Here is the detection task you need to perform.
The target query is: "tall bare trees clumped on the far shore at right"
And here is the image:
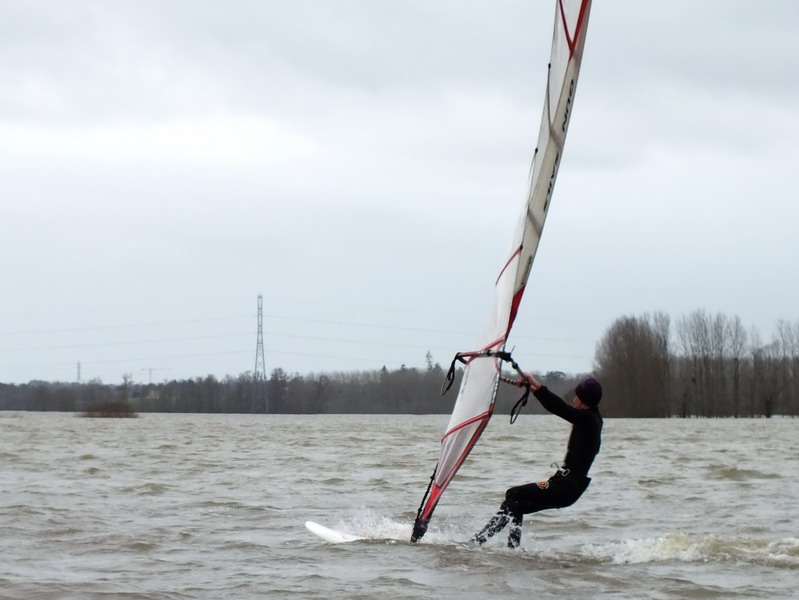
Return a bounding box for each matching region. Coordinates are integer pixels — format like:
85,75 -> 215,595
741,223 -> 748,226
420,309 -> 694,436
594,310 -> 799,417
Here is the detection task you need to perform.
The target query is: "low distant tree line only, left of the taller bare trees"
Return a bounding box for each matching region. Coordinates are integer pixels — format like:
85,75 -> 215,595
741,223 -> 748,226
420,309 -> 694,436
0,355 -> 577,414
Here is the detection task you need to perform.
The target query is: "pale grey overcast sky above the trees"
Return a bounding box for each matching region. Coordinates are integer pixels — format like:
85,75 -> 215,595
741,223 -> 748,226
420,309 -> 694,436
0,0 -> 799,383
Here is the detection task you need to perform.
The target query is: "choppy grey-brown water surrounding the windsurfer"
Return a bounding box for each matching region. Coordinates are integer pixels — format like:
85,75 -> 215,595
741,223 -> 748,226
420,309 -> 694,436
0,413 -> 799,600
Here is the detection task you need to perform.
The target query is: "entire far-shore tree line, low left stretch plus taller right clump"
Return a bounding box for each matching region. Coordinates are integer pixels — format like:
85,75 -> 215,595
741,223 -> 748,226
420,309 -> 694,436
0,310 -> 799,417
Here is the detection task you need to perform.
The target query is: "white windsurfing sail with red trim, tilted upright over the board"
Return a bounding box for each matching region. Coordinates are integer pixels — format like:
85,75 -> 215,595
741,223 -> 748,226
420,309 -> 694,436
411,0 -> 591,542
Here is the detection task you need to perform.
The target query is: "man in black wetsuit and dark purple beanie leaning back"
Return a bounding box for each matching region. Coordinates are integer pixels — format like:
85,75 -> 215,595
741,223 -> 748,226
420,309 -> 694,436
471,373 -> 602,548
